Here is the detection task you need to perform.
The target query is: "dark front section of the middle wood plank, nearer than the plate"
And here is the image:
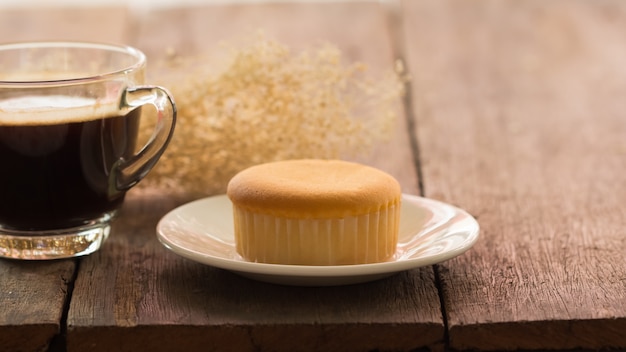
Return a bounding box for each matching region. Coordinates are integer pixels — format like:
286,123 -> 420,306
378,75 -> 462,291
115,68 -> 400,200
67,195 -> 443,351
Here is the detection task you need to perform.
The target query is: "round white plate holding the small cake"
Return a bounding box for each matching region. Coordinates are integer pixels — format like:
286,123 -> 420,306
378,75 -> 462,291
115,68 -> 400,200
157,194 -> 479,286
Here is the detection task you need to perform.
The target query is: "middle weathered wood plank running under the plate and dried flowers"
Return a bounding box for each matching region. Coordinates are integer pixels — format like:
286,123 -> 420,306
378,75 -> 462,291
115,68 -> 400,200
68,4 -> 444,351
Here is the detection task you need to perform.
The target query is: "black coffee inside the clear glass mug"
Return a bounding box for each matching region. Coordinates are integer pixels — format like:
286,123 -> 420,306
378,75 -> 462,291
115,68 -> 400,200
0,95 -> 140,230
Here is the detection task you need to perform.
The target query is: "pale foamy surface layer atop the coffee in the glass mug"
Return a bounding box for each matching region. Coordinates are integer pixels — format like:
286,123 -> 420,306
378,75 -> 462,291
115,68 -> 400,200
0,95 -> 119,126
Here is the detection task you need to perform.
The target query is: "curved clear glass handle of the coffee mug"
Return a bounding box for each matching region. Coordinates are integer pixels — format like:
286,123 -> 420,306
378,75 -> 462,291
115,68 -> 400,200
112,86 -> 176,191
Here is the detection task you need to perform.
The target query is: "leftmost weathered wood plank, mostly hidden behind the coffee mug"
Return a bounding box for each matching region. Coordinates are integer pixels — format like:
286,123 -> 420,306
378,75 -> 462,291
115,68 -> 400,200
0,8 -> 132,351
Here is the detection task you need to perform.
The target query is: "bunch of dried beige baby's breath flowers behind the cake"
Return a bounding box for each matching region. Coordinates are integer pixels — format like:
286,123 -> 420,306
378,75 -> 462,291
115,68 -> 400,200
143,34 -> 402,195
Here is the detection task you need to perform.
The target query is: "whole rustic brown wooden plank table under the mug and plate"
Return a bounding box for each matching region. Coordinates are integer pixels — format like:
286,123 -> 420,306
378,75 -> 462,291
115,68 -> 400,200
0,0 -> 626,351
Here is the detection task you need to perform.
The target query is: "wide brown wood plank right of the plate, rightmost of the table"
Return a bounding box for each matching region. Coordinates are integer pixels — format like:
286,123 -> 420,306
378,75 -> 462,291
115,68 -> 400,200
403,0 -> 626,350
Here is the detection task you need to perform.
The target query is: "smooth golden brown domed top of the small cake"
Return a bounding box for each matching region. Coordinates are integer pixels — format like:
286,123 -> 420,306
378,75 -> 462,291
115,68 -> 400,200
227,159 -> 401,218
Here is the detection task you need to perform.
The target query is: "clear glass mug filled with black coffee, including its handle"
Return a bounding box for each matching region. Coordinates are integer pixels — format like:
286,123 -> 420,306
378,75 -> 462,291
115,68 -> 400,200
0,42 -> 176,259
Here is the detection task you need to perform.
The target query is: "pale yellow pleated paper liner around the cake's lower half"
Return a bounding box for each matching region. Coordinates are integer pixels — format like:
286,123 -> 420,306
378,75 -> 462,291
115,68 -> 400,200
233,204 -> 400,265
